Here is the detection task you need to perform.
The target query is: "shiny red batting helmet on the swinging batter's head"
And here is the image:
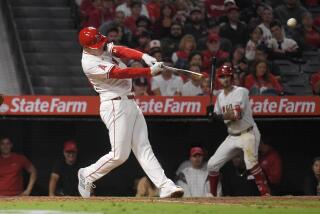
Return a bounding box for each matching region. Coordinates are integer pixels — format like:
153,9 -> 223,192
79,27 -> 108,49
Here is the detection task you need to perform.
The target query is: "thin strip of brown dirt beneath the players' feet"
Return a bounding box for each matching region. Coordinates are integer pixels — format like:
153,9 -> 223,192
0,196 -> 320,208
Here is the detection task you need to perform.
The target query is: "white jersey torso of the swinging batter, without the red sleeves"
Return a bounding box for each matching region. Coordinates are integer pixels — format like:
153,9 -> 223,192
81,43 -> 132,101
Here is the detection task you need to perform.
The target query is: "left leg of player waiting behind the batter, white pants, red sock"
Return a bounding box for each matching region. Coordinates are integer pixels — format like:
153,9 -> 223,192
208,136 -> 238,196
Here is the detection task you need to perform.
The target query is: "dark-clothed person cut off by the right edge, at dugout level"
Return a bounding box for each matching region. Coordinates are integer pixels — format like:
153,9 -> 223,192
303,157 -> 320,196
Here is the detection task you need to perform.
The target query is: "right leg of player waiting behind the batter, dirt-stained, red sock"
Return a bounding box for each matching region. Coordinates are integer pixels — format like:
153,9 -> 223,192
239,128 -> 270,195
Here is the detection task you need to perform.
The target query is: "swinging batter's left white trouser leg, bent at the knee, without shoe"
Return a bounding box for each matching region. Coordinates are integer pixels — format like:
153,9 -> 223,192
84,100 -> 136,182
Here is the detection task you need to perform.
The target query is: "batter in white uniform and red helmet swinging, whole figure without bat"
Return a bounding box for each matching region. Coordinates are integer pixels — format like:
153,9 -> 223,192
78,27 -> 184,198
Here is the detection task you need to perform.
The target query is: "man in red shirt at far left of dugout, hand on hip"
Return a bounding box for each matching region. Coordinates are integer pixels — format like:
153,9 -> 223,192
0,137 -> 37,196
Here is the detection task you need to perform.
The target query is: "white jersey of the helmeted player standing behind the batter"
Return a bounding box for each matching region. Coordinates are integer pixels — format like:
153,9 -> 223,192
214,86 -> 256,133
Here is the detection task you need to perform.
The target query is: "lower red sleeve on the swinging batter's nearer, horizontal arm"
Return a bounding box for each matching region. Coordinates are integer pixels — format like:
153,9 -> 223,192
107,66 -> 151,79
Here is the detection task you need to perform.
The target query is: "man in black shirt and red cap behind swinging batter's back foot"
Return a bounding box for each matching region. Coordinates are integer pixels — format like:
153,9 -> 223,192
49,141 -> 80,196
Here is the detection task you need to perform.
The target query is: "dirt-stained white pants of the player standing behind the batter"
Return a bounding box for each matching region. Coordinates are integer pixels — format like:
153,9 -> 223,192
208,126 -> 261,172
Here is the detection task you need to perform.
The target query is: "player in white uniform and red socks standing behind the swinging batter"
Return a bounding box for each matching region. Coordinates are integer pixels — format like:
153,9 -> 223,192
208,65 -> 270,195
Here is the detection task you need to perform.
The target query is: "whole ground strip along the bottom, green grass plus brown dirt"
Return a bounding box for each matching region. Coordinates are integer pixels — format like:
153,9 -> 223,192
0,197 -> 320,214
